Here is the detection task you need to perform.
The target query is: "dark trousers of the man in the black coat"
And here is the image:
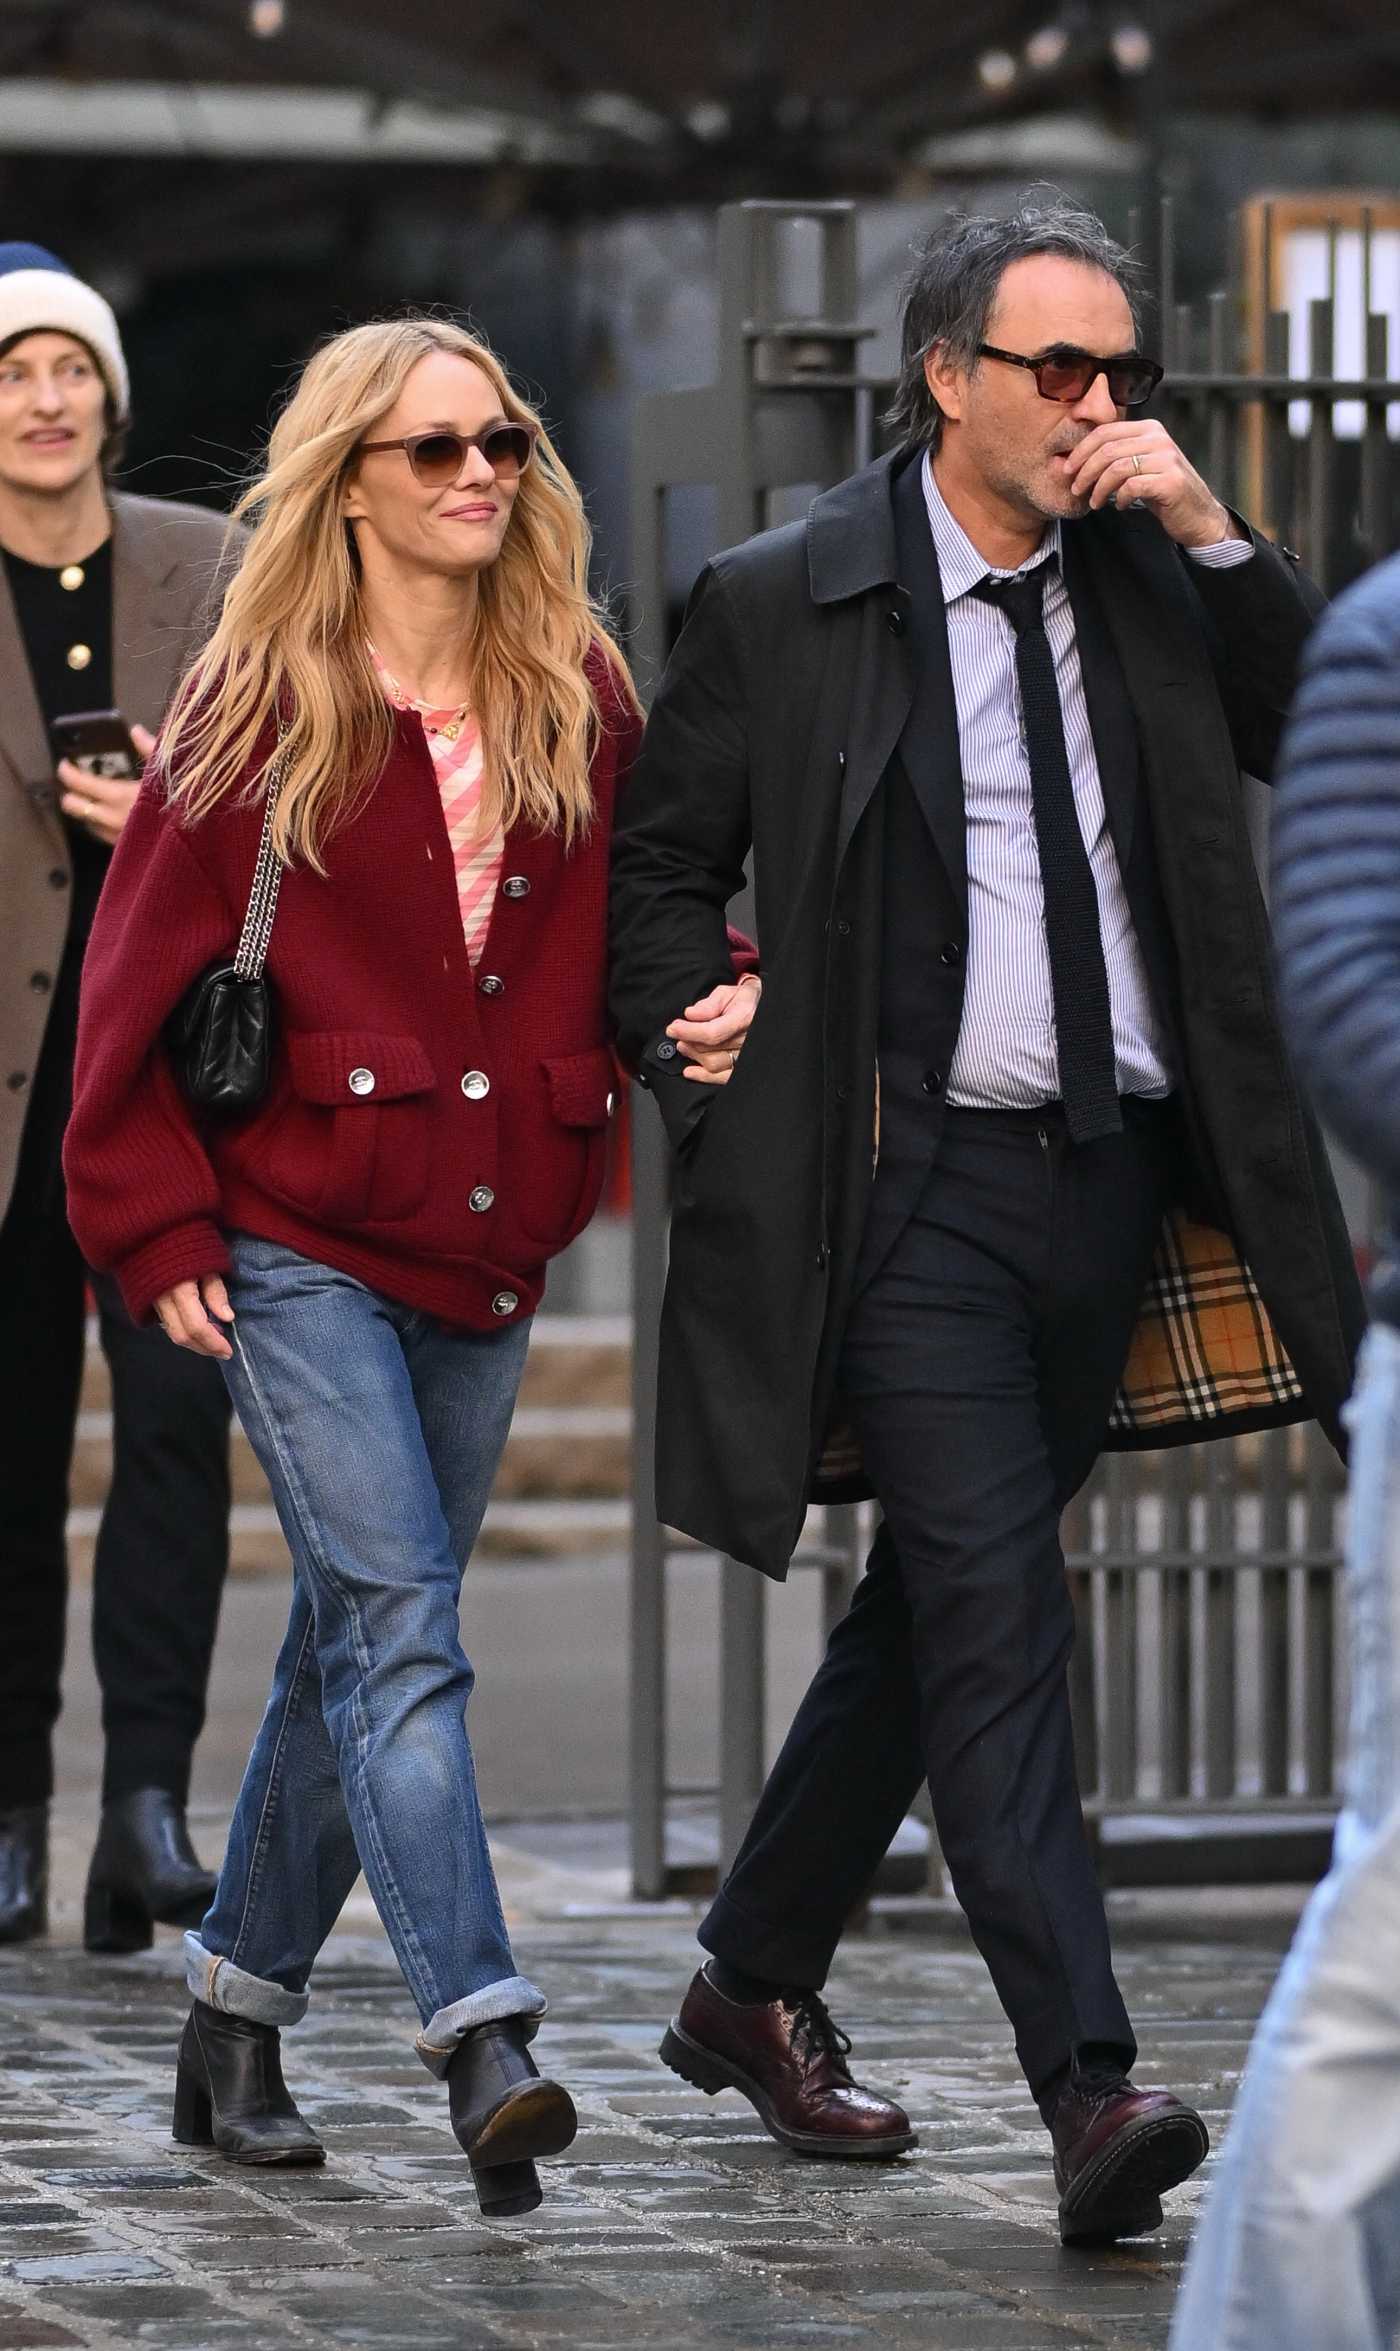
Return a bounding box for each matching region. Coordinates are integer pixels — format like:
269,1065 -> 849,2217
701,1100 -> 1179,2095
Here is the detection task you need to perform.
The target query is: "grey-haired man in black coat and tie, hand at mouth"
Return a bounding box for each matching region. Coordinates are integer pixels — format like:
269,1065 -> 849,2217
614,197 -> 1360,2243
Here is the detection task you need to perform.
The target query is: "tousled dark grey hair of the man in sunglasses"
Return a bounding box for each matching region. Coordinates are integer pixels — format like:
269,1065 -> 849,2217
885,188 -> 1146,449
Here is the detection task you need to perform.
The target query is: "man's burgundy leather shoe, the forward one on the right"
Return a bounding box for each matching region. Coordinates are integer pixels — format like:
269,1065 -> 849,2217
1049,2067 -> 1209,2245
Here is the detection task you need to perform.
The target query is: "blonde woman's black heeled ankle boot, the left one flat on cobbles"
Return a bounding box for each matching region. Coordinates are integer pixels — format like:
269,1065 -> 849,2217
172,2001 -> 325,2163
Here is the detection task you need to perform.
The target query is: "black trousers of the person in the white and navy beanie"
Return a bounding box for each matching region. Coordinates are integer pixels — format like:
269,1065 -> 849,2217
0,1168 -> 228,1808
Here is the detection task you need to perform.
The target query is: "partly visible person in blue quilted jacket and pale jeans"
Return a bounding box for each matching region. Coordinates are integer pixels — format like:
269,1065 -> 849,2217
1172,557 -> 1400,2351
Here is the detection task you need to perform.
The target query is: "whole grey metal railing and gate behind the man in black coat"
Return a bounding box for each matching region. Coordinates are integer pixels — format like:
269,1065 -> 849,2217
631,205 -> 1400,1897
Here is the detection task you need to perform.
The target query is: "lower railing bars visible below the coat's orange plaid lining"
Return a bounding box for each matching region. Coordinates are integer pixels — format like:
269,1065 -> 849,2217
1064,1425 -> 1346,1881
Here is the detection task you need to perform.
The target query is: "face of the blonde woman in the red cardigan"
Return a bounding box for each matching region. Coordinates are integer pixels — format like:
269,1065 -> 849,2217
346,350 -> 520,578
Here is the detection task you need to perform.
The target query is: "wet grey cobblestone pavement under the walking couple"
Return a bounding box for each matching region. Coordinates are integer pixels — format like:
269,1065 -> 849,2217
0,1848 -> 1308,2351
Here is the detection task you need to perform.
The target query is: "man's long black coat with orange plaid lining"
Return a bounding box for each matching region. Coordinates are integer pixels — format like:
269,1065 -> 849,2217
612,444 -> 1362,1578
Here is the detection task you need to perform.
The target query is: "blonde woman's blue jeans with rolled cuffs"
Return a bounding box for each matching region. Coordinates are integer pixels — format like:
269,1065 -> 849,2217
186,1232 -> 546,2074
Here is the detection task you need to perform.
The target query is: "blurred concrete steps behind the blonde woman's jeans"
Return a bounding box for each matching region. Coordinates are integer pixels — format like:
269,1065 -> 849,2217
68,1312 -> 631,1578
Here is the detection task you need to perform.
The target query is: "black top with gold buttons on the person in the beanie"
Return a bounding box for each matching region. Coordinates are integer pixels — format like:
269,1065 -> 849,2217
0,538 -> 113,1215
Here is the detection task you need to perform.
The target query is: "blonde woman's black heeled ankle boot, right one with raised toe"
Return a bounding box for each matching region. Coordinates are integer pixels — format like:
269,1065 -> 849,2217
447,2017 -> 579,2219
